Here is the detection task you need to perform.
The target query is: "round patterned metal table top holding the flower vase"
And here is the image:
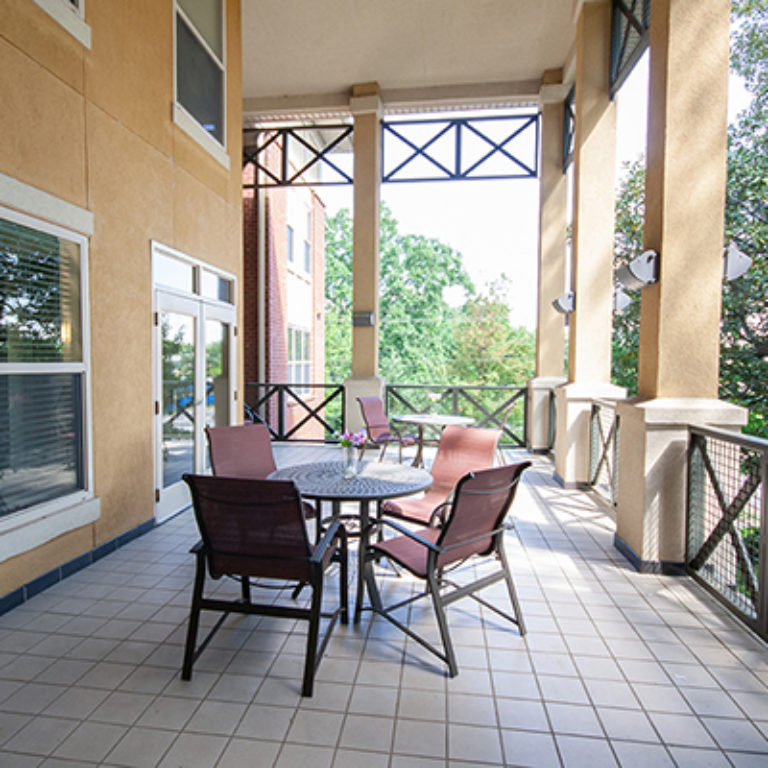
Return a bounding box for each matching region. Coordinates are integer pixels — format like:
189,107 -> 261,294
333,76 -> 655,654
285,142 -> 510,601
269,460 -> 432,501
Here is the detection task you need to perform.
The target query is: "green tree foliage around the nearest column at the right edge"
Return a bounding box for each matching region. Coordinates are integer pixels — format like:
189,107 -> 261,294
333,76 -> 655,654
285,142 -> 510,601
613,0 -> 768,437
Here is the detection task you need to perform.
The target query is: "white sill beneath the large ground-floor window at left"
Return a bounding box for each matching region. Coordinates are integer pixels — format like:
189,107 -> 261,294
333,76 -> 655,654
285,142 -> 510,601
0,495 -> 101,562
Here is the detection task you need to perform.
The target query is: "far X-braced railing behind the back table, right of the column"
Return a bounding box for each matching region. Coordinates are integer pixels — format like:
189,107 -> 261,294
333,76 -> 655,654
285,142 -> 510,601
386,384 -> 527,448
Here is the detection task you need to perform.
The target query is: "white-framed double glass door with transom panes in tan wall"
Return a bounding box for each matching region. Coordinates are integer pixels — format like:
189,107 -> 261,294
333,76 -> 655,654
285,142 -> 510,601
154,291 -> 235,519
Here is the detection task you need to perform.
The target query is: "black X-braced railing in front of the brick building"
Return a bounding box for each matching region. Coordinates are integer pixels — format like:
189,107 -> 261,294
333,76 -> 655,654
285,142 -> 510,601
243,382 -> 345,443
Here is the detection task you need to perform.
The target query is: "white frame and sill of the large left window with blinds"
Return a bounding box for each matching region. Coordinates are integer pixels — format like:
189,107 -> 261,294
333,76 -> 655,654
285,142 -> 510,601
0,204 -> 100,562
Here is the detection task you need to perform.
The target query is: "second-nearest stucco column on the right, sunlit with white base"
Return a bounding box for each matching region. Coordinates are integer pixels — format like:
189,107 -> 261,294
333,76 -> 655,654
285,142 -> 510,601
555,0 -> 625,485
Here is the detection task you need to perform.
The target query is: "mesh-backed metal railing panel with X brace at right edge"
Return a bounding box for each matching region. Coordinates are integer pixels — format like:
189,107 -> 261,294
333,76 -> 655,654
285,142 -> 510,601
685,427 -> 768,639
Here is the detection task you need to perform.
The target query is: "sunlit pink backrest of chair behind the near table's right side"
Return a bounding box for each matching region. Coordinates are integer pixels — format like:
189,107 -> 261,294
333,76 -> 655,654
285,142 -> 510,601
429,424 -> 501,499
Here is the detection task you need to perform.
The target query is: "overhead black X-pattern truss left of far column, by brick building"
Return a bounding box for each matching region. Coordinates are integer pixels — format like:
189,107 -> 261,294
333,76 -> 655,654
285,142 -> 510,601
243,124 -> 352,189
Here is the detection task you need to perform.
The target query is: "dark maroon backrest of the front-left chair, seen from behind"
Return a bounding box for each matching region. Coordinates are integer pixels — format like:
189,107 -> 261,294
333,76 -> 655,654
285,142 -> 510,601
183,474 -> 312,581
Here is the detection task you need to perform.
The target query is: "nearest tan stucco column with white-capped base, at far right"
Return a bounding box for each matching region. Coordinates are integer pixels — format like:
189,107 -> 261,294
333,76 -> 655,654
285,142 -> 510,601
616,0 -> 747,570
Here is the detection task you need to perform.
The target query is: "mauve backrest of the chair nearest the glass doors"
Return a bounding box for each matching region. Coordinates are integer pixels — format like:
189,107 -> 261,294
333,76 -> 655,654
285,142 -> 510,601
205,424 -> 277,480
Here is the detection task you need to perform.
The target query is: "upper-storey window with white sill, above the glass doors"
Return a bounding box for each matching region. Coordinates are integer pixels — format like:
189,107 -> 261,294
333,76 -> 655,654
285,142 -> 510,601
175,0 -> 226,162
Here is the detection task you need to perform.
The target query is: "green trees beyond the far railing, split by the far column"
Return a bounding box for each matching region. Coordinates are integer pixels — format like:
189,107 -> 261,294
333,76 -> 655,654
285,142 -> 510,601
325,206 -> 534,385
